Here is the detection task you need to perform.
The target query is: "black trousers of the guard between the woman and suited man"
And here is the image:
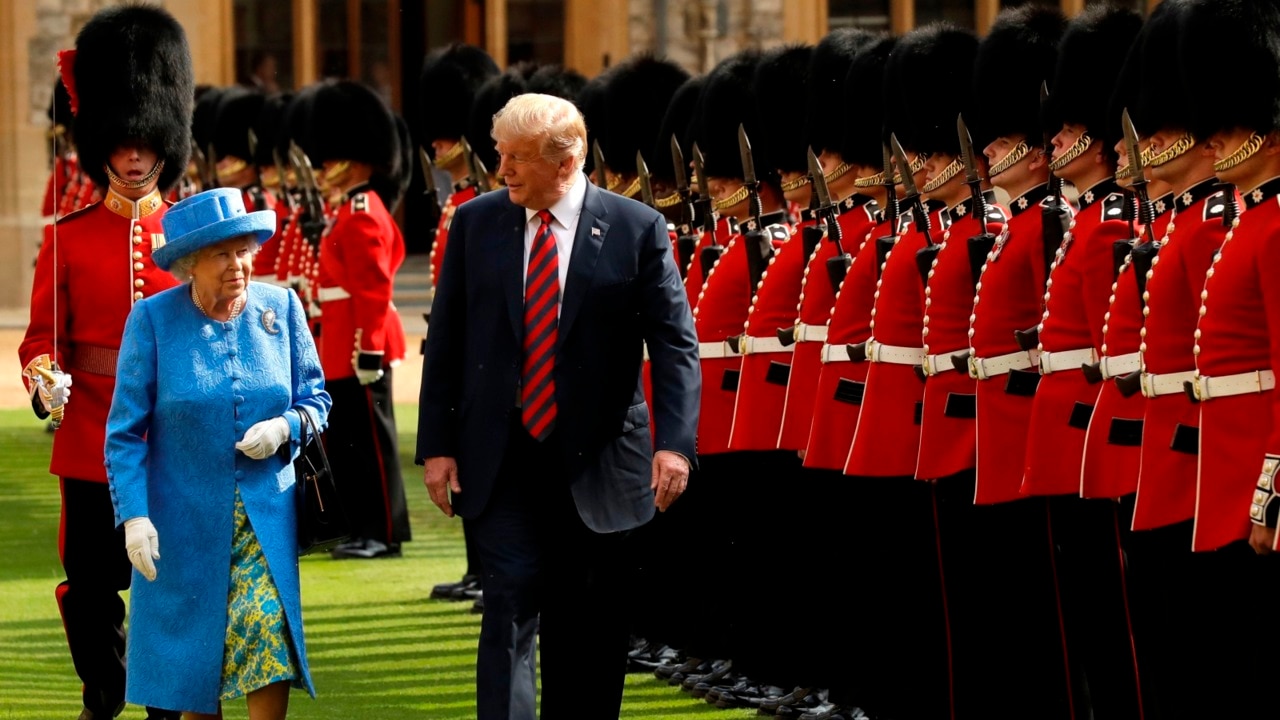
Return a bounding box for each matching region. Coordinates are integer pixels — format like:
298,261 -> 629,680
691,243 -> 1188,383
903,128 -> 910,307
324,368 -> 411,544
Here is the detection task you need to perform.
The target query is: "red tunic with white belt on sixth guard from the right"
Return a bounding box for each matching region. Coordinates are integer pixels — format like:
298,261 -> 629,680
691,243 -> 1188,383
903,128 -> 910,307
915,193 -> 1007,480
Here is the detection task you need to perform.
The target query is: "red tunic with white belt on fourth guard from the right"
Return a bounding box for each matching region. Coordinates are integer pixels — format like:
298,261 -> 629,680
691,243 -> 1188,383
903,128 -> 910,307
1021,179 -> 1130,495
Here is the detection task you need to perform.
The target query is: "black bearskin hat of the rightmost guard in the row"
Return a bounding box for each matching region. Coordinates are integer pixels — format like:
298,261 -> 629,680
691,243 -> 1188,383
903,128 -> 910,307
1176,0 -> 1280,139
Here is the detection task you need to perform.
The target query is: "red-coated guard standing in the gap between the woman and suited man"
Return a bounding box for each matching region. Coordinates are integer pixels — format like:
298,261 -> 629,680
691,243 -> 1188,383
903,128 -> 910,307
311,81 -> 410,559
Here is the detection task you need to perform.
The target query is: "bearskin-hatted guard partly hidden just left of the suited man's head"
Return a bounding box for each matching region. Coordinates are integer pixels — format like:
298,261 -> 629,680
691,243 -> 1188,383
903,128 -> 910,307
419,42 -> 499,293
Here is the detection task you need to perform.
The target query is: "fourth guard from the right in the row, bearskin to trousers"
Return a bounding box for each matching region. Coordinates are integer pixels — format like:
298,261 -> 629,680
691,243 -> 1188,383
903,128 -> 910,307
1021,5 -> 1142,717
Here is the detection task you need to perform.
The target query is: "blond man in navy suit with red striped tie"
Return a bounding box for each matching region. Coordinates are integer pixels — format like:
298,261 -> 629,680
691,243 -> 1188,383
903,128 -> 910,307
416,94 -> 701,720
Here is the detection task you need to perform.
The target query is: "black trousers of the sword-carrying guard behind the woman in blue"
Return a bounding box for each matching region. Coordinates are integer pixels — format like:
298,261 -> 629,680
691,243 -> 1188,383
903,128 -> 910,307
55,478 -> 178,719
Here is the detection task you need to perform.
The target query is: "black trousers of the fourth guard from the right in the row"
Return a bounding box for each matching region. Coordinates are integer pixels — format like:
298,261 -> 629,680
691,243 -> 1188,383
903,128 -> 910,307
1050,496 -> 1142,720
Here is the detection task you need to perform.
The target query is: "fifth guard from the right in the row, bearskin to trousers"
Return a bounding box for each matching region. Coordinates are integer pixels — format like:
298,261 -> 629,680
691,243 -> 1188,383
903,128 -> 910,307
962,5 -> 1073,719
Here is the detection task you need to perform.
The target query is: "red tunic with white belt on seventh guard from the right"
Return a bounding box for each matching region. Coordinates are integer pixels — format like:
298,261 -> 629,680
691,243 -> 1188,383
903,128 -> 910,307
845,204 -> 943,477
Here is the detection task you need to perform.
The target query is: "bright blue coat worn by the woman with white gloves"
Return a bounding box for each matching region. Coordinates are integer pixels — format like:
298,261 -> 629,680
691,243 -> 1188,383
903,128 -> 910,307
106,283 -> 330,712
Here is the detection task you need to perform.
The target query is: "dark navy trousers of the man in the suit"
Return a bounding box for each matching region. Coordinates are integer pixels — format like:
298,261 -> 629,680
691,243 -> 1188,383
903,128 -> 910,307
473,414 -> 627,720
